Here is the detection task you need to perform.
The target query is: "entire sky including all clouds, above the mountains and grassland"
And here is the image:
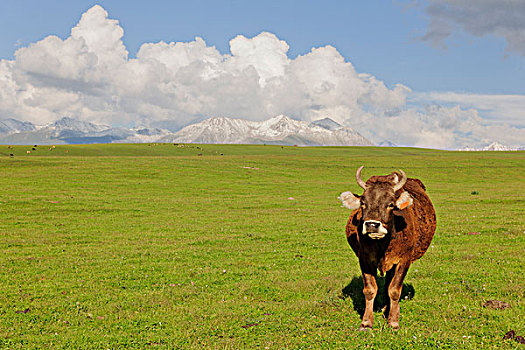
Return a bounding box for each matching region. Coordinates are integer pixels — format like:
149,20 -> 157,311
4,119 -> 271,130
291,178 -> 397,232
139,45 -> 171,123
0,0 -> 525,149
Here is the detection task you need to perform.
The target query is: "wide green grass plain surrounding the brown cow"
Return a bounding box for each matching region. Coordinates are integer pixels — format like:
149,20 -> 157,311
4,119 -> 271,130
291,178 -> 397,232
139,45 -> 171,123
0,144 -> 525,349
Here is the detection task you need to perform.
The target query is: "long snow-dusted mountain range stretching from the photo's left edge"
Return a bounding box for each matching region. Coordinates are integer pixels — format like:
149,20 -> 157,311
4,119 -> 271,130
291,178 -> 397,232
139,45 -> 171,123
0,115 -> 373,146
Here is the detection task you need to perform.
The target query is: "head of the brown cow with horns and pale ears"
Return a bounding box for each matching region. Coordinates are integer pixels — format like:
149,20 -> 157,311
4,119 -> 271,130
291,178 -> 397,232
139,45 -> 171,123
339,167 -> 412,239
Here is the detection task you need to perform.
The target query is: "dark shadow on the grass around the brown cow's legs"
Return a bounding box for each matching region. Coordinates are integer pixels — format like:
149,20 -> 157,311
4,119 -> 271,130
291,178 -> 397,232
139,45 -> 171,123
342,276 -> 416,317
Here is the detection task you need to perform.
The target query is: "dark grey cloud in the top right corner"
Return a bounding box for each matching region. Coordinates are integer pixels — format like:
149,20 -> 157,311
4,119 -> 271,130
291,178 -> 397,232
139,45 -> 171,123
423,0 -> 525,55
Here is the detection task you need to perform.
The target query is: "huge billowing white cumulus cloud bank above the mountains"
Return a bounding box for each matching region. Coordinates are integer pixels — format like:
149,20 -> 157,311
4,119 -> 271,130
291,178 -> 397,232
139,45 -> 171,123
0,5 -> 521,148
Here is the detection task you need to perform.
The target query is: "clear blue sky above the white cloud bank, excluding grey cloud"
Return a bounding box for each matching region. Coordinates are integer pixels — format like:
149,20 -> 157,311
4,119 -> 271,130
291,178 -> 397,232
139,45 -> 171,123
0,0 -> 525,94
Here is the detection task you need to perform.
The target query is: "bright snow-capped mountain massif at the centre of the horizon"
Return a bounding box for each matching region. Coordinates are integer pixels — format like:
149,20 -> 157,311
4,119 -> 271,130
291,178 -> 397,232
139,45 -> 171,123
160,115 -> 373,146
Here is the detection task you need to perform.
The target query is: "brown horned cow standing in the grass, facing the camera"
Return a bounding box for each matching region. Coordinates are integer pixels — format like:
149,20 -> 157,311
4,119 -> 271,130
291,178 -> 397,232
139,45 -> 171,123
339,166 -> 436,331
